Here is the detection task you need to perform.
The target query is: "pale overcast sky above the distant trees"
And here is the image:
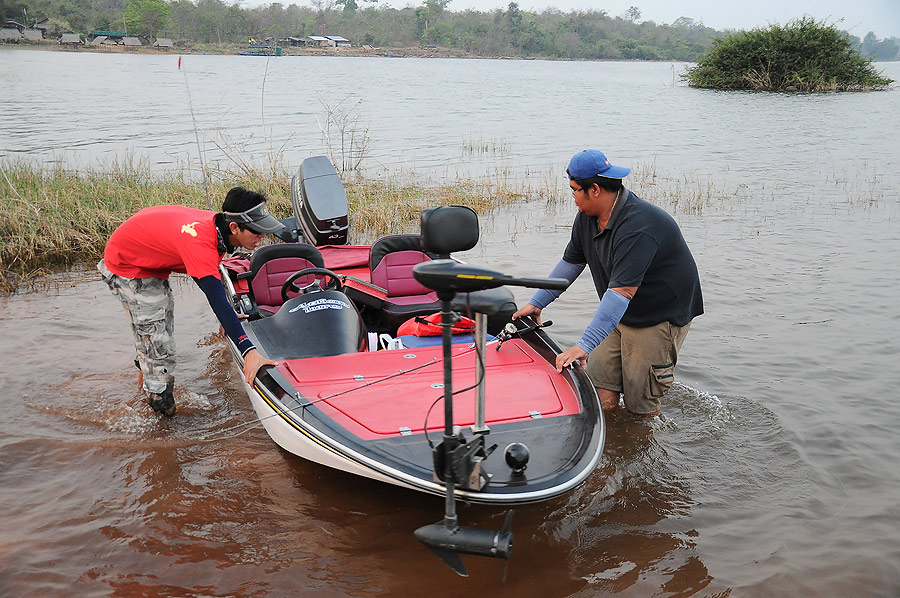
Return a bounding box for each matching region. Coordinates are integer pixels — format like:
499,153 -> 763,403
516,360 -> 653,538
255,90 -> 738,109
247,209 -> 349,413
260,0 -> 900,39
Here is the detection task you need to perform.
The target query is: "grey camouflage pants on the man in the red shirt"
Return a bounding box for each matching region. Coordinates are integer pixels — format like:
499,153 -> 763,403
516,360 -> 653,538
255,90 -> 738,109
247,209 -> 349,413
97,260 -> 175,393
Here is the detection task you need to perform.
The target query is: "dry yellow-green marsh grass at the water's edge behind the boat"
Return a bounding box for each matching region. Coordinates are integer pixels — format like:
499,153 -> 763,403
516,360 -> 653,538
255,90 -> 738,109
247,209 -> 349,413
0,162 -> 559,293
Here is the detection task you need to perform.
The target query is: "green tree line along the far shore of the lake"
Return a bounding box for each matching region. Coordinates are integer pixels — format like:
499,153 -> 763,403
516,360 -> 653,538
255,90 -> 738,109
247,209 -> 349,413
0,0 -> 900,61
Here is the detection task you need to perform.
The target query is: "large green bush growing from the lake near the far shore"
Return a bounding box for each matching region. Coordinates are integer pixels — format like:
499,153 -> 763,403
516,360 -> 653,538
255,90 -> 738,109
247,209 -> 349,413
682,17 -> 893,92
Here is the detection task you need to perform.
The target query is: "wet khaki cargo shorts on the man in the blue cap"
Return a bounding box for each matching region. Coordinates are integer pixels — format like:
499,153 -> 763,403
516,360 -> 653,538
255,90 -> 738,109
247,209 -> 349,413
587,322 -> 691,413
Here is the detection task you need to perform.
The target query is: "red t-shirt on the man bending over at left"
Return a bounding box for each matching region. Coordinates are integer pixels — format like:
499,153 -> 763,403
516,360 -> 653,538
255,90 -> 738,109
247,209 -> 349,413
103,206 -> 222,280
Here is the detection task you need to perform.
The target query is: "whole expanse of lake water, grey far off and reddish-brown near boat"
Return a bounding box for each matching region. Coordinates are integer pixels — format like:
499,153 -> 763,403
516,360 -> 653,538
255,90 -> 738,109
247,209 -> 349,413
0,50 -> 900,598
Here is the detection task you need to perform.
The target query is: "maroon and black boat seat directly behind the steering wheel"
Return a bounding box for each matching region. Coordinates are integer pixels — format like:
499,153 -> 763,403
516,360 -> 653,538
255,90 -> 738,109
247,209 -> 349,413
238,243 -> 324,319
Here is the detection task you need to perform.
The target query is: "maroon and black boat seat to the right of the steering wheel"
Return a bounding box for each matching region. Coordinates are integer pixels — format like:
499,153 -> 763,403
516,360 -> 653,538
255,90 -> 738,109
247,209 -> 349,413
369,234 -> 441,328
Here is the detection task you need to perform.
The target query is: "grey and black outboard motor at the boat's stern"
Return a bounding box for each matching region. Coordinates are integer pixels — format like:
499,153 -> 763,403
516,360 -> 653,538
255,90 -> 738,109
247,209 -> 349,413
291,156 -> 350,246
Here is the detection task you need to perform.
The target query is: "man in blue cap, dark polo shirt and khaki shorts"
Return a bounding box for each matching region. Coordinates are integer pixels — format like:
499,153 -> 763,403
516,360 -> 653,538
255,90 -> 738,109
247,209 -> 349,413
513,149 -> 703,415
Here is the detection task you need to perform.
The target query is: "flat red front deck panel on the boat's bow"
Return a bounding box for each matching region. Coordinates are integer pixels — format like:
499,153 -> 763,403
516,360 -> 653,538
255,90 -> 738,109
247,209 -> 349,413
278,339 -> 580,440
